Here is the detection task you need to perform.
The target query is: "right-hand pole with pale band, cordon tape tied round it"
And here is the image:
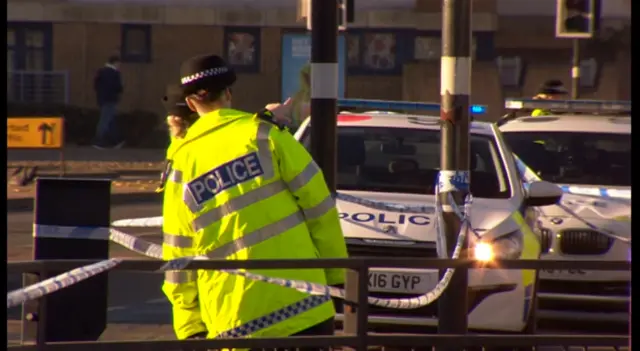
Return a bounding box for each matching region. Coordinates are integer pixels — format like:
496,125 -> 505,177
438,0 -> 472,350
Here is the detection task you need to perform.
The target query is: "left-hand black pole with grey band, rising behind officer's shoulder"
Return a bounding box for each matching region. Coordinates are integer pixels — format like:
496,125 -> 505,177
311,0 -> 338,192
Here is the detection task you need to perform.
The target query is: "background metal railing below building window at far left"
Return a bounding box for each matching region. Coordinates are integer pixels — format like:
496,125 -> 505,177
7,71 -> 69,104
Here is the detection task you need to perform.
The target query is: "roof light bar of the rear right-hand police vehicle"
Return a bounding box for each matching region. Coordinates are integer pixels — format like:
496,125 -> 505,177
504,99 -> 631,113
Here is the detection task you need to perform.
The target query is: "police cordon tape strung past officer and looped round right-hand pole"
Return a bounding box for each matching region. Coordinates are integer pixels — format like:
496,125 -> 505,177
7,171 -> 473,310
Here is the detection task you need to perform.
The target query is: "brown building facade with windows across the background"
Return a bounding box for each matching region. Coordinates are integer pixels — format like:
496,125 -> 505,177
7,0 -> 631,118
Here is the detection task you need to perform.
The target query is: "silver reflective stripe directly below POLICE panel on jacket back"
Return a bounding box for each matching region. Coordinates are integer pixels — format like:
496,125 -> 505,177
192,181 -> 287,231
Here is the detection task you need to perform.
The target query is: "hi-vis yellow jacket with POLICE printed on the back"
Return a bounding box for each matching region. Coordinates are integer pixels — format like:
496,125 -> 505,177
162,109 -> 347,339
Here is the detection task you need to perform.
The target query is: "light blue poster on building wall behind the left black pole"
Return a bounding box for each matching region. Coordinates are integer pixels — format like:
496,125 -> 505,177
281,34 -> 346,125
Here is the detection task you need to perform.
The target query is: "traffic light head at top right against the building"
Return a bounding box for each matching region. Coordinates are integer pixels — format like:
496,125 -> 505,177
556,0 -> 601,39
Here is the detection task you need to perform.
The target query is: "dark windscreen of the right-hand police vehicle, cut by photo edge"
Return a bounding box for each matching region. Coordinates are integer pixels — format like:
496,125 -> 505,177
503,132 -> 631,186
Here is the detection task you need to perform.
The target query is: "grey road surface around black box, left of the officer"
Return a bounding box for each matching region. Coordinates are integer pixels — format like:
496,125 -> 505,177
7,201 -> 628,351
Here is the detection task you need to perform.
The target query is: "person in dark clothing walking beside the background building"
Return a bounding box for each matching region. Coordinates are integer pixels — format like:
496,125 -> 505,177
93,56 -> 124,149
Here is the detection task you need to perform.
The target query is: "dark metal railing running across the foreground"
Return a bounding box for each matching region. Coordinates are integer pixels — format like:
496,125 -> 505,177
7,258 -> 631,351
